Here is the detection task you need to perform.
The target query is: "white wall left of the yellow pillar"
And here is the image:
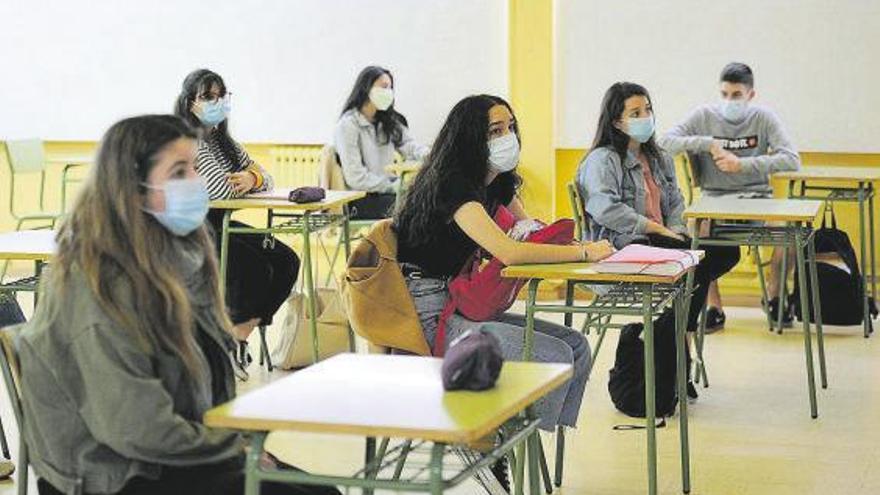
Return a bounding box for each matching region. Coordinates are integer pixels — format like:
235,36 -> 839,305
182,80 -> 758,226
0,0 -> 508,143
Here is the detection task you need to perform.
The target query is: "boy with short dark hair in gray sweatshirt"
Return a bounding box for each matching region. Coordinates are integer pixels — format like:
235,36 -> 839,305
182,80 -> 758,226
658,62 -> 801,332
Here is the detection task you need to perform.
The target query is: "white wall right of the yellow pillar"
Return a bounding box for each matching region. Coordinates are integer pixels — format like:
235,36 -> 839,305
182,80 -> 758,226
556,0 -> 880,152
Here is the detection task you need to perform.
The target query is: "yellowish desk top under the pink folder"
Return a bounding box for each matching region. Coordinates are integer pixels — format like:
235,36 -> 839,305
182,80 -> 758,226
501,263 -> 687,284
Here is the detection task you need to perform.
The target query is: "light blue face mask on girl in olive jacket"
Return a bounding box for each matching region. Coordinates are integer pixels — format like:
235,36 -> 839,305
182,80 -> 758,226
144,177 -> 208,236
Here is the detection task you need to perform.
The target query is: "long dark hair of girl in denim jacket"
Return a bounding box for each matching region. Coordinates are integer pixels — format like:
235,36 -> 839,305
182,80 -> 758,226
591,82 -> 661,163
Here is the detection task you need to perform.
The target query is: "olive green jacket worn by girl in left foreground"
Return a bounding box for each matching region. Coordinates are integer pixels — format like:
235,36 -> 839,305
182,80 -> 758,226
16,248 -> 244,494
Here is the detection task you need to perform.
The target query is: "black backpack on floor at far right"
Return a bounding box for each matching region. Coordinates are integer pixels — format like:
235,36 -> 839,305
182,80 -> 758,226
789,207 -> 877,325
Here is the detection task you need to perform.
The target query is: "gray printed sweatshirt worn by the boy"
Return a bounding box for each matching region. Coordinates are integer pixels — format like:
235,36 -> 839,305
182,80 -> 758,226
658,104 -> 801,195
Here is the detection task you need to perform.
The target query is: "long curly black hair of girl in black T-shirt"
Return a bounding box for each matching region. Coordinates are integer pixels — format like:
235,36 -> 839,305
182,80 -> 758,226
394,95 -> 522,245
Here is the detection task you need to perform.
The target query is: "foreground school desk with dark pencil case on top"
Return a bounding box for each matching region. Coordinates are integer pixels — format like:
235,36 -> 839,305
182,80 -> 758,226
204,354 -> 572,495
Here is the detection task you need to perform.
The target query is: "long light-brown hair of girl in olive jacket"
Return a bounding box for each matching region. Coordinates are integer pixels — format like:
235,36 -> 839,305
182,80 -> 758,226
38,115 -> 231,380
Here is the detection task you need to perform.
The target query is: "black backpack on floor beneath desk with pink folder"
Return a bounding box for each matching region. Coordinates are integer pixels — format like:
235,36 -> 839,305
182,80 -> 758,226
608,311 -> 690,418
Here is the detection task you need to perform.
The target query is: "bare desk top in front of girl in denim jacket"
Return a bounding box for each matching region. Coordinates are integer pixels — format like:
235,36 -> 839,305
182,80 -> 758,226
684,196 -> 822,222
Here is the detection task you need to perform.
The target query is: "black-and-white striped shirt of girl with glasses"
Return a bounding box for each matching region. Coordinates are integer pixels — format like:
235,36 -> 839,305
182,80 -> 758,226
196,129 -> 274,200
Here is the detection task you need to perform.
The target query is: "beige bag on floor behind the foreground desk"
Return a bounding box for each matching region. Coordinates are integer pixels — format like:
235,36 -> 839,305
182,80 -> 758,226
271,288 -> 349,369
